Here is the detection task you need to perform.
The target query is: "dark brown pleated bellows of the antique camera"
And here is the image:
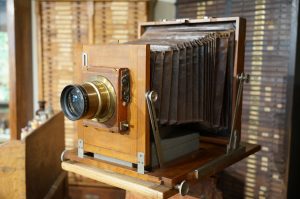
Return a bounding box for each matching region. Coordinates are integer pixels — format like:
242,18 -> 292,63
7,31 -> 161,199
128,27 -> 234,129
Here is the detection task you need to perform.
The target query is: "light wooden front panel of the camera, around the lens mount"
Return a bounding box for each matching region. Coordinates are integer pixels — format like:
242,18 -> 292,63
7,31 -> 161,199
76,44 -> 150,165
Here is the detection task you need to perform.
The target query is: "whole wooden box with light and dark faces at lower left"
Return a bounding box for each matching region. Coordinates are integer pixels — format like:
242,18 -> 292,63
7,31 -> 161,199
0,112 -> 66,199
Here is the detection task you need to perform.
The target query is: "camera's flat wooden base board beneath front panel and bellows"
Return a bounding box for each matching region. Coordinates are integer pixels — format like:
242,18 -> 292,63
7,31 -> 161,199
64,143 -> 260,188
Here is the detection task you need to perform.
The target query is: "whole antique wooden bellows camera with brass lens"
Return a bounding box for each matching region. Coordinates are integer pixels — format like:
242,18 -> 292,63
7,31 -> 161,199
61,17 -> 252,190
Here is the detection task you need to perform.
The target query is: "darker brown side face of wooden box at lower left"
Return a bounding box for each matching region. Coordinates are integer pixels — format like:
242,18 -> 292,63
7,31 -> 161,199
25,112 -> 65,198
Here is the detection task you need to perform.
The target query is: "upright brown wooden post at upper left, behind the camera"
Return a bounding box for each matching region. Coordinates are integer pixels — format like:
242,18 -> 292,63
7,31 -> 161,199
7,0 -> 33,139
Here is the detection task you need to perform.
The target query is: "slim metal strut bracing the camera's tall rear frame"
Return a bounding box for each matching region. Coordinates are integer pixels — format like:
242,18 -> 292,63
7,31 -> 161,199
227,73 -> 250,154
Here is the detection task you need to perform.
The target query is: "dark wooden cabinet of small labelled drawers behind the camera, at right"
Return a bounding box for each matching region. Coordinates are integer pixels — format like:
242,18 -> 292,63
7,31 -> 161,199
177,0 -> 293,198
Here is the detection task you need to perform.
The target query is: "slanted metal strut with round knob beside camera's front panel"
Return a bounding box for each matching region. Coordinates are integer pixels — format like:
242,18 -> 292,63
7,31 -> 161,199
146,91 -> 164,167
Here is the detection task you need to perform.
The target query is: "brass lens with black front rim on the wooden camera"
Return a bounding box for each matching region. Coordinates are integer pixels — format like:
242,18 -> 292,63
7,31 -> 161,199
61,76 -> 116,122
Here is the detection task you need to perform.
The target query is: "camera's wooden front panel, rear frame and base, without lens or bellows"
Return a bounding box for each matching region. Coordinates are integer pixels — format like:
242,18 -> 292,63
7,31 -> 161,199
65,17 -> 259,190
